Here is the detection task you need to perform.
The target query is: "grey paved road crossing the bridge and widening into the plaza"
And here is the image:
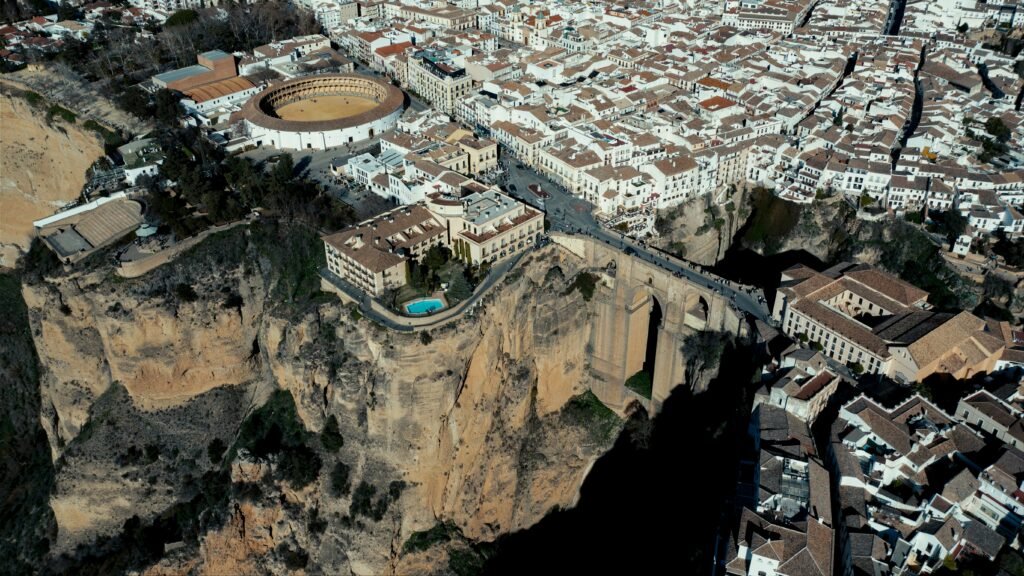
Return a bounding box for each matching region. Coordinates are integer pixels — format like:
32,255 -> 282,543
500,156 -> 771,322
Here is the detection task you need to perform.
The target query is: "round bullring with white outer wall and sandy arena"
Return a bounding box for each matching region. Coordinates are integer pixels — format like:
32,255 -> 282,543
240,74 -> 406,150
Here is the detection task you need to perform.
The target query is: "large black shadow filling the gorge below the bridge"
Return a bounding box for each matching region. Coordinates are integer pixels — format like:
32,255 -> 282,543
483,338 -> 756,575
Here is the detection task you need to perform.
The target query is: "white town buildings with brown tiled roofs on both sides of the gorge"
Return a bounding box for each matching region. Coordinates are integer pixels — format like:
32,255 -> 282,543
9,0 -> 1024,576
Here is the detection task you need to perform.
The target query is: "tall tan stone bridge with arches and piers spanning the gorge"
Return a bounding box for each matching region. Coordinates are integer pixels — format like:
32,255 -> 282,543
551,234 -> 746,414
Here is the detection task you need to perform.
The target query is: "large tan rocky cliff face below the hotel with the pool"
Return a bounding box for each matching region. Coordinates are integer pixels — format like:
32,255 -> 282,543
23,223 -> 618,574
